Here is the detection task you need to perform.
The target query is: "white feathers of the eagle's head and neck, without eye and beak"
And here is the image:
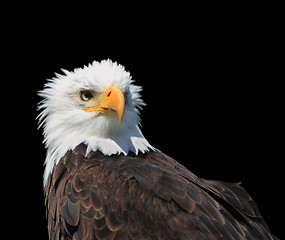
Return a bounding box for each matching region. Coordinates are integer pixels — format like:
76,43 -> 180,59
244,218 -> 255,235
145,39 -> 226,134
38,60 -> 154,184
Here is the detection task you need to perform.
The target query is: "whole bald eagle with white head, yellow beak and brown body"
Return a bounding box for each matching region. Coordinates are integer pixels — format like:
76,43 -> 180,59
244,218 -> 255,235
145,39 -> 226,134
38,60 -> 276,240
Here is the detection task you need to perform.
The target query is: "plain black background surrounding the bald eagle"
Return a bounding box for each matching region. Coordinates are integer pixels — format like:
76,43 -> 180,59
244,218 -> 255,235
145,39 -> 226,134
0,4 -> 285,239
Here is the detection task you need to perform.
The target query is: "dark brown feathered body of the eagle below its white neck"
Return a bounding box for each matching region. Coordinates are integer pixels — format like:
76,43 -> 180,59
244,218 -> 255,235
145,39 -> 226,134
45,144 -> 276,240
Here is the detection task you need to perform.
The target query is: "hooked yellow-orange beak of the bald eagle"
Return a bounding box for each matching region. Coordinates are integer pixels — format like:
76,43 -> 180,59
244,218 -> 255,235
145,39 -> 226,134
84,86 -> 125,125
